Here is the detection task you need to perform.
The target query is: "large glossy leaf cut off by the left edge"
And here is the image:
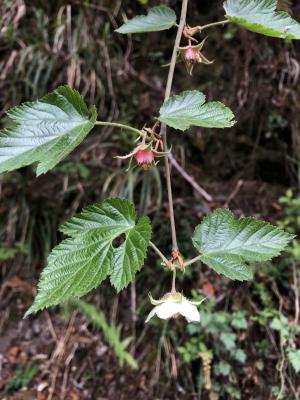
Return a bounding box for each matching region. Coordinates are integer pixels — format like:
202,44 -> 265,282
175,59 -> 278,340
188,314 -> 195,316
0,86 -> 97,175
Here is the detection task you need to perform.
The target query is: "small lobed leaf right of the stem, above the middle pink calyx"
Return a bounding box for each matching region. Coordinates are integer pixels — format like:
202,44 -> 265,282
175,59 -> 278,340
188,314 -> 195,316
159,90 -> 235,131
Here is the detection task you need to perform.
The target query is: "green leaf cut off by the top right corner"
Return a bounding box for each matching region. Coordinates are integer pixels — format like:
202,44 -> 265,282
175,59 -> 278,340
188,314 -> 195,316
224,0 -> 300,39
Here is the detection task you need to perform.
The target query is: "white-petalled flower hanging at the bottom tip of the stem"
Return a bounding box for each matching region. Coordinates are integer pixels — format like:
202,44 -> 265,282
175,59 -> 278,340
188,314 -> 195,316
146,292 -> 205,323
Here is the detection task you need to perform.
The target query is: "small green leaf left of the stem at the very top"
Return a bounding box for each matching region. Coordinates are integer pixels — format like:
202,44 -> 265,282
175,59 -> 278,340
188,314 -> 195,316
116,6 -> 176,33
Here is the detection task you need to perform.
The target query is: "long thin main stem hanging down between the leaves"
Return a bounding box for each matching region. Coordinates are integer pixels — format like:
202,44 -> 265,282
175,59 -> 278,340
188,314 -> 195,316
160,0 -> 188,255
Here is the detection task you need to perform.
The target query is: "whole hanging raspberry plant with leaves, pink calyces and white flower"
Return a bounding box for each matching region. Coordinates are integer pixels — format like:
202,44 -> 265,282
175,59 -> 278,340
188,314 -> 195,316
0,0 -> 300,321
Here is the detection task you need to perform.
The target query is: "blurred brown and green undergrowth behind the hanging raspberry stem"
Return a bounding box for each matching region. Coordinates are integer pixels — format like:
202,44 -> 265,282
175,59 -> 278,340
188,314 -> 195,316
0,0 -> 300,400
